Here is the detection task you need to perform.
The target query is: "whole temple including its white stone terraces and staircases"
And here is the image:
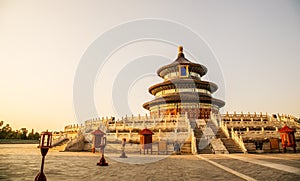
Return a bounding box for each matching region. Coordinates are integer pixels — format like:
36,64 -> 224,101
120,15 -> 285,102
53,47 -> 300,154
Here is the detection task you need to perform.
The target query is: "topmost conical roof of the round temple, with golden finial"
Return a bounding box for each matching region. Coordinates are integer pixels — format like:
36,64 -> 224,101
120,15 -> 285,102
157,46 -> 207,78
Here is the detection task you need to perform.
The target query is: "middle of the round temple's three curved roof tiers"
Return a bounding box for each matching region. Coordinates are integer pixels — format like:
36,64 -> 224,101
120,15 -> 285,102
149,78 -> 218,95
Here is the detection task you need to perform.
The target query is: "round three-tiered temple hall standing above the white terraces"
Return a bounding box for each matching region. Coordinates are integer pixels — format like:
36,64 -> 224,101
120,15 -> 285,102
143,47 -> 225,119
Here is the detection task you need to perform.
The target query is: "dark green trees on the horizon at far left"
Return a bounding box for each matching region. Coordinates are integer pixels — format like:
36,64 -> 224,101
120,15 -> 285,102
0,121 -> 40,140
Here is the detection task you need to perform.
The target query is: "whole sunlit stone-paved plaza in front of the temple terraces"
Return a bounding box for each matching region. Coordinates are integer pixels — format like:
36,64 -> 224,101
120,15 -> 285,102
0,146 -> 300,181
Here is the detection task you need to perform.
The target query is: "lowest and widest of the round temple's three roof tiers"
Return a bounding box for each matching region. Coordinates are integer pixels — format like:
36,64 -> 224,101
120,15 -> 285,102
143,92 -> 225,110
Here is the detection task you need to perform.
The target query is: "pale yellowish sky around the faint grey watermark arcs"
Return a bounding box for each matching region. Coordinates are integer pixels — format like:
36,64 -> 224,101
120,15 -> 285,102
0,0 -> 300,131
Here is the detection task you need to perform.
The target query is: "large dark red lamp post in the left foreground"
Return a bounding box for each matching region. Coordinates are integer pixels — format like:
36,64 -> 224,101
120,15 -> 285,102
35,131 -> 52,181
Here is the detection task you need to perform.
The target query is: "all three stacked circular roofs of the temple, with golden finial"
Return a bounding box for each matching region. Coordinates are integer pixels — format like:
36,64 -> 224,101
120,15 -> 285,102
143,47 -> 225,110
